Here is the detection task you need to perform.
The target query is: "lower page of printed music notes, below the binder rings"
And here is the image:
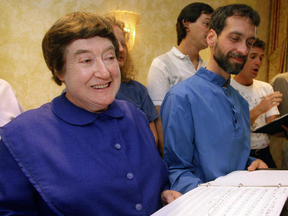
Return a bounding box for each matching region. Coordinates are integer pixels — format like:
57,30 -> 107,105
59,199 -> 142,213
152,187 -> 288,216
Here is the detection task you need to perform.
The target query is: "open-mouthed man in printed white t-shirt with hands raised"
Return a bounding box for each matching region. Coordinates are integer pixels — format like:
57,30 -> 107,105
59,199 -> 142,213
231,38 -> 282,168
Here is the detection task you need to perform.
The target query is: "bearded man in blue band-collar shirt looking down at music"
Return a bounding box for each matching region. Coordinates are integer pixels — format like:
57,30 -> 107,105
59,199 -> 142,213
161,4 -> 267,193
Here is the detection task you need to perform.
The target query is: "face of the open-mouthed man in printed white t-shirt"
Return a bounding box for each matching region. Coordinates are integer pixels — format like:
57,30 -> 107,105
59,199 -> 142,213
241,47 -> 264,79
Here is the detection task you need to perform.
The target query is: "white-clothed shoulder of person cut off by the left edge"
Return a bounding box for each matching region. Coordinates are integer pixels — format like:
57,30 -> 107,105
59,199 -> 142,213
0,79 -> 24,127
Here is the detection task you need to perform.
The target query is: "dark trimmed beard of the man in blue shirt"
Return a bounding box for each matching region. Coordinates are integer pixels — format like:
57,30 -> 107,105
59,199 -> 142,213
213,43 -> 247,75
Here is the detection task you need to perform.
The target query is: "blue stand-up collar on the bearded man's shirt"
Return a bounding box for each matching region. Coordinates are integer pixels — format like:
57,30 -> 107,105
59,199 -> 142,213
195,67 -> 231,87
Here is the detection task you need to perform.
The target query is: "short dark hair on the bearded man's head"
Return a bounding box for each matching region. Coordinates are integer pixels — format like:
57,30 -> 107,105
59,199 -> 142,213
210,4 -> 260,35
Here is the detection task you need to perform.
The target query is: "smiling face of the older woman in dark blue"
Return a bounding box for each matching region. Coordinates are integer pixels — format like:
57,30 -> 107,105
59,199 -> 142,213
59,36 -> 121,112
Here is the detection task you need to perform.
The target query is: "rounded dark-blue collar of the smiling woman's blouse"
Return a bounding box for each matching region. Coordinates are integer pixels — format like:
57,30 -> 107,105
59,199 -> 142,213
51,93 -> 125,125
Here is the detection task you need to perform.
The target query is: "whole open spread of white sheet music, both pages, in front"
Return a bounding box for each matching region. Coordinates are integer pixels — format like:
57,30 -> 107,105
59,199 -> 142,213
152,170 -> 288,216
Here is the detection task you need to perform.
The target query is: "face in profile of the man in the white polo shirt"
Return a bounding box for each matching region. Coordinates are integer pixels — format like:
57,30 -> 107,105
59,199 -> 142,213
186,14 -> 211,50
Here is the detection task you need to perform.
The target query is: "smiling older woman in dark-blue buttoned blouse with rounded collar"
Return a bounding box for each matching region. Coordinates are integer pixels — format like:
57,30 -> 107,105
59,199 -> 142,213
0,13 -> 179,216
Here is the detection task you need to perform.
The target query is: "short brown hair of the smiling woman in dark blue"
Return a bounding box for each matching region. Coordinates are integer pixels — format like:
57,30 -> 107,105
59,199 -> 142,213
42,12 -> 119,86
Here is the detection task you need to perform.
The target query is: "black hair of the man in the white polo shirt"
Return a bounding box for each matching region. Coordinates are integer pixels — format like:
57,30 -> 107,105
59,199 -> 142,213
176,2 -> 214,45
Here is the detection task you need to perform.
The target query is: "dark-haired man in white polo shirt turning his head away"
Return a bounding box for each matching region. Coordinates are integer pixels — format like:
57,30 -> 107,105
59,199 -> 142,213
147,2 -> 214,113
